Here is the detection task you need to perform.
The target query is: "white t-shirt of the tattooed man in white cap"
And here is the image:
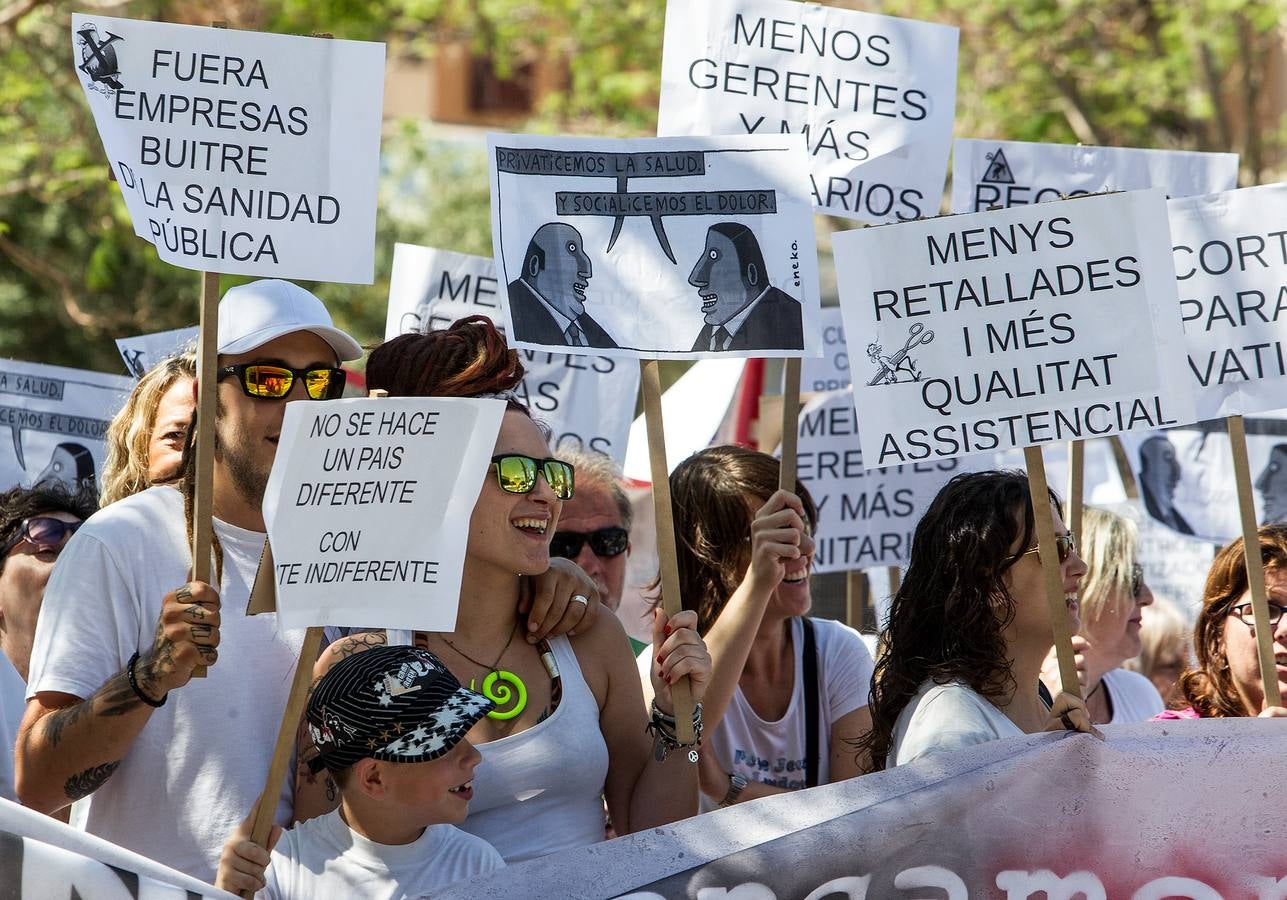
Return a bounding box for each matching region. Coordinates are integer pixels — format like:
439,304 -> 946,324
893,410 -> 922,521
27,487 -> 304,882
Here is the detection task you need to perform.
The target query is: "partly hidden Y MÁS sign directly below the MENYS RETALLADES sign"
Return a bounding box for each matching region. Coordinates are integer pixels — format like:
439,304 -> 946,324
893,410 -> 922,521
797,390 -> 972,574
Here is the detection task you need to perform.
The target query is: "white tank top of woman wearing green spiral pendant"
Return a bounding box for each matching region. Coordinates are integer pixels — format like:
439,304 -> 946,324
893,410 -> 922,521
461,637 -> 607,865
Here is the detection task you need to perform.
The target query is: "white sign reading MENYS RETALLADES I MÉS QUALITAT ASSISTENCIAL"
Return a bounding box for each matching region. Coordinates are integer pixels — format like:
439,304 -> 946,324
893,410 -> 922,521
835,189 -> 1193,467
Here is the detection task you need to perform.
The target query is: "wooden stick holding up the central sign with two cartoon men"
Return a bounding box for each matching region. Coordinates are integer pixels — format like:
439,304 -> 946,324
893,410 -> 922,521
640,359 -> 695,744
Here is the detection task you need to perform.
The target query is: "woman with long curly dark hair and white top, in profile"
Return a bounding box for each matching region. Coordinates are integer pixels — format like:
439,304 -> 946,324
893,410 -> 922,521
861,471 -> 1094,769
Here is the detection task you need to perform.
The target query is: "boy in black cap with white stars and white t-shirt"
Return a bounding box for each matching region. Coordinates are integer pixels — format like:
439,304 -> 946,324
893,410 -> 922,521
215,646 -> 505,900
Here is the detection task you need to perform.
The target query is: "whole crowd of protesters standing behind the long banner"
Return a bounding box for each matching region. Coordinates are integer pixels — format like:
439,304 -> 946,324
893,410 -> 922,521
0,281 -> 1287,899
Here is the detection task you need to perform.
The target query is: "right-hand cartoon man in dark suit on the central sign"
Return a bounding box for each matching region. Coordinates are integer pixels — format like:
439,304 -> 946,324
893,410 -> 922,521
689,221 -> 804,352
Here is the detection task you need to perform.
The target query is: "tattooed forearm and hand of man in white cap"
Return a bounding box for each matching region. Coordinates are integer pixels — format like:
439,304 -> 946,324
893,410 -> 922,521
14,582 -> 219,812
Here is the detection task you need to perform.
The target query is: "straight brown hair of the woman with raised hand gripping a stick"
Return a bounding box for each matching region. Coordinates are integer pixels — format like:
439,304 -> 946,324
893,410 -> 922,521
654,445 -> 817,635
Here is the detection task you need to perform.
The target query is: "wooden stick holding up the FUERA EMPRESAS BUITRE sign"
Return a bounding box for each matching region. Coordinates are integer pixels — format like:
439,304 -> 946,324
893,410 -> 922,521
192,272 -> 219,679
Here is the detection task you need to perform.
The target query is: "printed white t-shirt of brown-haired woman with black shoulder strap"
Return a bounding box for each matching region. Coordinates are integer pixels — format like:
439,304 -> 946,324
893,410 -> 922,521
700,618 -> 873,812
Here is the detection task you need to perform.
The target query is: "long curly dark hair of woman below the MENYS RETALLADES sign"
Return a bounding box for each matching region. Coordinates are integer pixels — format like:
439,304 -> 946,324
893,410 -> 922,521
857,471 -> 1059,771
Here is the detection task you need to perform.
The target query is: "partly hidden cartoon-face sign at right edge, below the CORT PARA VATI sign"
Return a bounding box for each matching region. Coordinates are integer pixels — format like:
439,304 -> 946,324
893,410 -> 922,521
1122,415 -> 1287,545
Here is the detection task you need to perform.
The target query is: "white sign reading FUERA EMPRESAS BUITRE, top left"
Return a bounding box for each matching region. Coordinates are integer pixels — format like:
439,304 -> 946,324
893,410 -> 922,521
71,14 -> 385,285
